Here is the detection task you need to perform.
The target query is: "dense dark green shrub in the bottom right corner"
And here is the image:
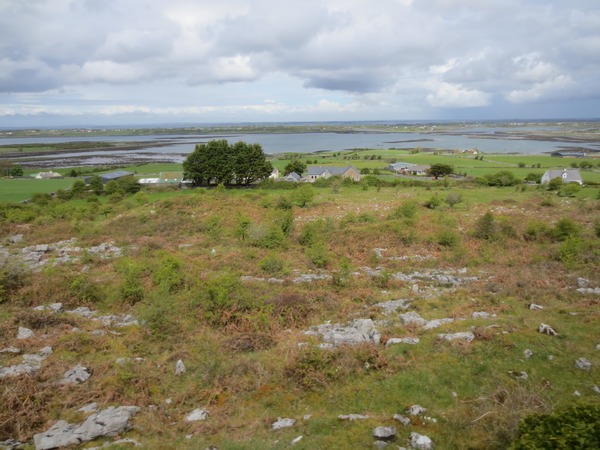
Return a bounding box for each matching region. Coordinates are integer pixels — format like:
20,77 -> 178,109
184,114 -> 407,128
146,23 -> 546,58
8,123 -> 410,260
510,405 -> 600,450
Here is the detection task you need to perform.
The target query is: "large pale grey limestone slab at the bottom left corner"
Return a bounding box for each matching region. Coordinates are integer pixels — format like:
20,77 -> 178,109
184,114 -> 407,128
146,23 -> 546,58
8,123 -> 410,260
33,406 -> 140,450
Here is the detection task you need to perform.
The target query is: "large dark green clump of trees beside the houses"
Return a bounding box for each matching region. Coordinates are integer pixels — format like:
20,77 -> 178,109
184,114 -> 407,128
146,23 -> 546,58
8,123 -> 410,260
183,139 -> 273,185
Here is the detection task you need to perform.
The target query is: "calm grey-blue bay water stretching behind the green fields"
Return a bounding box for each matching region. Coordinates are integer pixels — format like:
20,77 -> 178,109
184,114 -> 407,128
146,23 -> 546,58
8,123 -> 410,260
5,128 -> 600,167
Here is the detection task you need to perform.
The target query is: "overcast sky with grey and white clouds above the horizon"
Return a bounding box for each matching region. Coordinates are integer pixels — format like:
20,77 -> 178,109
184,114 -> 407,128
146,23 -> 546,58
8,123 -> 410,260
0,0 -> 600,127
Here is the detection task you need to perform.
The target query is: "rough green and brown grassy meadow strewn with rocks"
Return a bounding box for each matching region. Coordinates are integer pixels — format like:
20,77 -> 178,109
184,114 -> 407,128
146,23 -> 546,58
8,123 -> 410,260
0,147 -> 600,450
